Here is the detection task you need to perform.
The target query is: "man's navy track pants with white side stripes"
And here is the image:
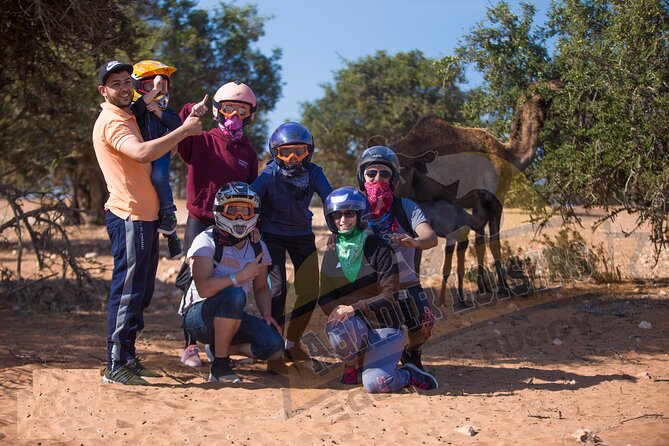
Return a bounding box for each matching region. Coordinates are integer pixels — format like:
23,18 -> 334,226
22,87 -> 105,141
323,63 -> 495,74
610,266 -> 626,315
105,211 -> 158,370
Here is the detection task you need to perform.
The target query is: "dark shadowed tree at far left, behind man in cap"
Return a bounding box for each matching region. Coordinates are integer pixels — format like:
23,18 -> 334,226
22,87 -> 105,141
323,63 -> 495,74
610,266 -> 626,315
0,0 -> 143,225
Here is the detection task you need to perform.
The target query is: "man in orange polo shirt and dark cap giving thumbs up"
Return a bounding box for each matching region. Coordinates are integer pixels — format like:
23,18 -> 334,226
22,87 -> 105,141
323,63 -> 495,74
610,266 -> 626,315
93,60 -> 207,385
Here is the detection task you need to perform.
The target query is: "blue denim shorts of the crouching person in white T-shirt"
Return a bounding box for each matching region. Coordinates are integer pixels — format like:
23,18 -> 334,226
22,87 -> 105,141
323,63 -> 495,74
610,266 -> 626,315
184,287 -> 283,360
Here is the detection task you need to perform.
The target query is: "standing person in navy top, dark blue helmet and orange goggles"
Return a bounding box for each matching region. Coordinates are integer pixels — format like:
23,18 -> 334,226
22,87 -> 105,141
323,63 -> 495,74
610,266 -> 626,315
251,122 -> 332,360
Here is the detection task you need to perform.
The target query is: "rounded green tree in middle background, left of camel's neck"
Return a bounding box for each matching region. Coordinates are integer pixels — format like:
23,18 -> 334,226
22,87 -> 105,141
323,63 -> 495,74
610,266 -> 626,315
302,51 -> 464,185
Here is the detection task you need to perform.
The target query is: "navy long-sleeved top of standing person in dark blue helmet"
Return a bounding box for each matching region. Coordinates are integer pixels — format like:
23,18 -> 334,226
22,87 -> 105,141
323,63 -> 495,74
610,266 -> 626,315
251,160 -> 332,236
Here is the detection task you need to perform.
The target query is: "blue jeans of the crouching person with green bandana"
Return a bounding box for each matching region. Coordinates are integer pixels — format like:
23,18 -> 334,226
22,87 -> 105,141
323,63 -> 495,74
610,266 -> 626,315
325,316 -> 409,393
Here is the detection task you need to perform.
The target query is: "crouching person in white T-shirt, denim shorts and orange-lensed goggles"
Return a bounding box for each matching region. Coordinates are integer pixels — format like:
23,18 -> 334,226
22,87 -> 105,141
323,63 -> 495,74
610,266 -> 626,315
179,182 -> 283,383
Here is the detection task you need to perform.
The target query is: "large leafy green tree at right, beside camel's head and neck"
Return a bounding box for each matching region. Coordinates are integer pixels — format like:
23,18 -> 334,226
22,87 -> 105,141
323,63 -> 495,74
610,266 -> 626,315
456,0 -> 669,247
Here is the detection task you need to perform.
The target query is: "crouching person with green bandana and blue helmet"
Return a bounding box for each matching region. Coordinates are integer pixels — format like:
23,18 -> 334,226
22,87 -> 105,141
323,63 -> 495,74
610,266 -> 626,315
319,187 -> 437,393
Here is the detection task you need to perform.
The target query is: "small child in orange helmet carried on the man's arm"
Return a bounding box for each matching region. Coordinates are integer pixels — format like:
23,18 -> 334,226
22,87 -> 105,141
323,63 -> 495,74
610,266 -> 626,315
131,60 -> 182,259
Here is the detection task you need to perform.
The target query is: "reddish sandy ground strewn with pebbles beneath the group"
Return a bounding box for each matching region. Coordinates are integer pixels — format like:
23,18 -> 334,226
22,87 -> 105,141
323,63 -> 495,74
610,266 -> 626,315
0,200 -> 669,445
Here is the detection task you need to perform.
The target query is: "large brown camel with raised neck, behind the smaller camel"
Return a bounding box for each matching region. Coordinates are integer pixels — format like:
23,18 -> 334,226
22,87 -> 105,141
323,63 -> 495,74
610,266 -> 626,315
390,81 -> 562,304
